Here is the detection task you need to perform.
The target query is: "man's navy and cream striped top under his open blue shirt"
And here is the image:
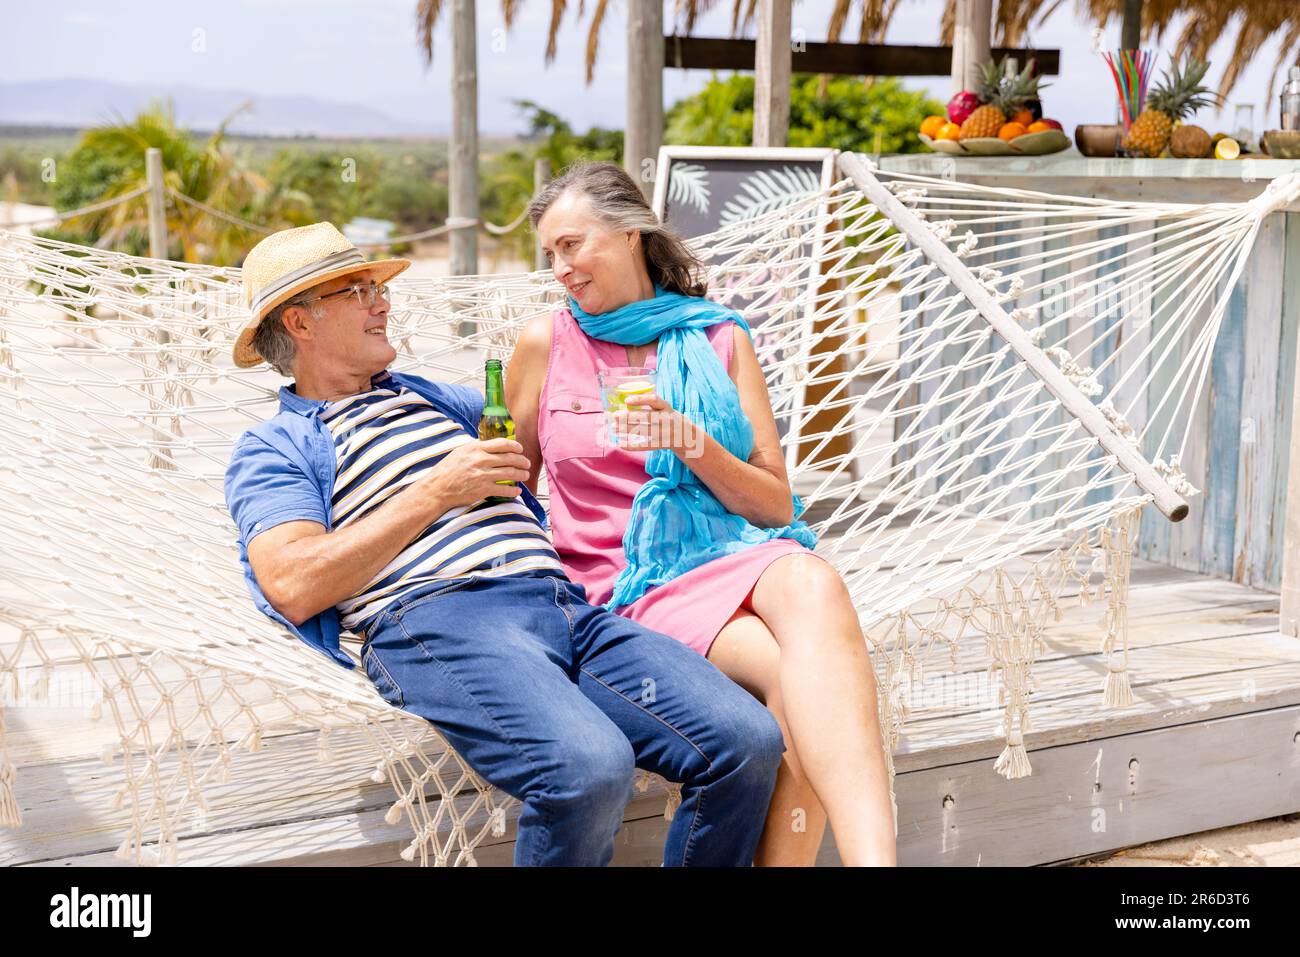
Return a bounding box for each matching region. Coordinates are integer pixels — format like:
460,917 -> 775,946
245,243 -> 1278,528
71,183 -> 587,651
321,386 -> 564,633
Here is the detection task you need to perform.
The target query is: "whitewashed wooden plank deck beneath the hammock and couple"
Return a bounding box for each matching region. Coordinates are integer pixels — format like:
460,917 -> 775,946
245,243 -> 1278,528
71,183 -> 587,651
0,548 -> 1300,866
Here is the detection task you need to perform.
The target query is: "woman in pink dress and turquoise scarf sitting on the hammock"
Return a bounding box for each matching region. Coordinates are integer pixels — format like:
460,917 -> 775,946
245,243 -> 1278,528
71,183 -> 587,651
506,163 -> 894,866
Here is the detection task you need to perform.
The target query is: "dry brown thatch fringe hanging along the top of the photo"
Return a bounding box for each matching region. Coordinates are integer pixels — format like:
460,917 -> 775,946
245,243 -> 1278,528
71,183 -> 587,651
416,0 -> 1300,99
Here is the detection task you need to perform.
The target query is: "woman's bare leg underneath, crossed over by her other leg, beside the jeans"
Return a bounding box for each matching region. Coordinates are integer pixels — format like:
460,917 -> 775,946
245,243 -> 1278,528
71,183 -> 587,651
709,609 -> 826,867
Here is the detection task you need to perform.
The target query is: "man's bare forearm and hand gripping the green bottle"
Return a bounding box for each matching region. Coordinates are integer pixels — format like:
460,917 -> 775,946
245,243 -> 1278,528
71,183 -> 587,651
248,438 -> 528,625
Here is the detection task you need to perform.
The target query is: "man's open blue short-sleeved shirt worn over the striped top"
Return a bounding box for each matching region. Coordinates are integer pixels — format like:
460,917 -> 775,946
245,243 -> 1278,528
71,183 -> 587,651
225,371 -> 546,668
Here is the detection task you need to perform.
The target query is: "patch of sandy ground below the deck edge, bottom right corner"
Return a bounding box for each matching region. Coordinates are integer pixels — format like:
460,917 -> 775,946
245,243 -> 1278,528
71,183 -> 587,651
1070,814 -> 1300,867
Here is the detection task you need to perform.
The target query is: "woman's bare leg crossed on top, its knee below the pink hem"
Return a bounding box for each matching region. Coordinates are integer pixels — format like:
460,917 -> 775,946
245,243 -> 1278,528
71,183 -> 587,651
748,554 -> 897,866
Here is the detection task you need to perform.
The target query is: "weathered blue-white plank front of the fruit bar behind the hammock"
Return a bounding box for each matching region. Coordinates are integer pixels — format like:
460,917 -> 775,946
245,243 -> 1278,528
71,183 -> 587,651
901,179 -> 1300,592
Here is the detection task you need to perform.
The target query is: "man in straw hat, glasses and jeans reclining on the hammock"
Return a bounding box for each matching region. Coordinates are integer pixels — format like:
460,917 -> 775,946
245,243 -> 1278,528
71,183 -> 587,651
225,222 -> 785,866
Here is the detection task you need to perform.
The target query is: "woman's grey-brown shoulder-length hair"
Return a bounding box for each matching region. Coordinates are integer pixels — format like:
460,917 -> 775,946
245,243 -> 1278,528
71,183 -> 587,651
528,163 -> 709,296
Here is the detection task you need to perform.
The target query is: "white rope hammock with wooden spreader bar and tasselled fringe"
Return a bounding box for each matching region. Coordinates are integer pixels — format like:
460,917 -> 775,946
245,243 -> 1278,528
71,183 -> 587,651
0,155 -> 1300,865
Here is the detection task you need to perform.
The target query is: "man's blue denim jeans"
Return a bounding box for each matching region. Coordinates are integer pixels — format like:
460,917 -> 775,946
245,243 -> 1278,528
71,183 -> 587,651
361,576 -> 785,867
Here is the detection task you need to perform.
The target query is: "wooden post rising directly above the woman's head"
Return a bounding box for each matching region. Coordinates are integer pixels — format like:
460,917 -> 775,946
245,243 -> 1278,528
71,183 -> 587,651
623,3 -> 664,202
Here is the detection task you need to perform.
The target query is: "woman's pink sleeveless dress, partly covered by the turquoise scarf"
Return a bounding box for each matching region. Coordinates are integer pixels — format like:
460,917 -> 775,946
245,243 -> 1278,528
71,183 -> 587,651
537,307 -> 814,654
